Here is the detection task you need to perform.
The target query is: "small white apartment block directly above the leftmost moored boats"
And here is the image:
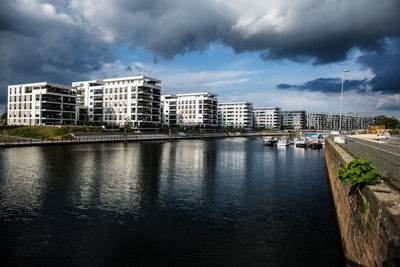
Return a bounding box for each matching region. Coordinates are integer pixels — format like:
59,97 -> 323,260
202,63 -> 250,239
253,107 -> 281,130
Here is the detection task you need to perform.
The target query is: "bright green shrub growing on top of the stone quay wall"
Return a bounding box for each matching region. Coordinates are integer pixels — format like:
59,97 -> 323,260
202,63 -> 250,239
336,159 -> 380,187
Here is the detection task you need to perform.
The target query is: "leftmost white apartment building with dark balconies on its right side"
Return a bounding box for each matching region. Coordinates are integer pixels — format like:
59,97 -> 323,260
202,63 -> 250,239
7,82 -> 76,125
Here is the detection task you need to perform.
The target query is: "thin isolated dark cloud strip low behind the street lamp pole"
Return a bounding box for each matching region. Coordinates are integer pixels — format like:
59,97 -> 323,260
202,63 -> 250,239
277,78 -> 367,93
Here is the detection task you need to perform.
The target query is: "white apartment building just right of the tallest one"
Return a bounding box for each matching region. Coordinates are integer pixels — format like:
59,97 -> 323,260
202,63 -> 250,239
162,92 -> 218,128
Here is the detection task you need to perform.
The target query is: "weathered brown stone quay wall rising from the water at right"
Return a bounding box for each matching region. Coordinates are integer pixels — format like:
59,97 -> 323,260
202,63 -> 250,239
325,138 -> 400,266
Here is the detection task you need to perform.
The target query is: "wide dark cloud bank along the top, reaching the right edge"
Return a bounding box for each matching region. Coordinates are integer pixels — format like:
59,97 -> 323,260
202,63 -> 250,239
71,0 -> 400,64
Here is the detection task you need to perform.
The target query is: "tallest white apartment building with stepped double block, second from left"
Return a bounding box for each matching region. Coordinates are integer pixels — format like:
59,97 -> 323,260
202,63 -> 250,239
72,76 -> 161,129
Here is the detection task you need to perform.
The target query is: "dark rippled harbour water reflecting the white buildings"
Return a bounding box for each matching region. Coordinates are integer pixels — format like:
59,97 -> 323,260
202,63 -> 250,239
0,138 -> 343,266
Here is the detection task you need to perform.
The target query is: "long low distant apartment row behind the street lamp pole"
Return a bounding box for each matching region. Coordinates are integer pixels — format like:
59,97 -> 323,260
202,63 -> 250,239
307,113 -> 372,131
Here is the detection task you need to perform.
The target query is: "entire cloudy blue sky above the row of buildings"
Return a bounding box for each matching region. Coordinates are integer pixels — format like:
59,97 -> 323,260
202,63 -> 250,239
0,0 -> 400,118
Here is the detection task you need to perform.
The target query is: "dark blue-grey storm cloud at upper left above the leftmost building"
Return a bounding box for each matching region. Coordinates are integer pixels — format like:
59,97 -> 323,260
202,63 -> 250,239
0,1 -> 114,103
